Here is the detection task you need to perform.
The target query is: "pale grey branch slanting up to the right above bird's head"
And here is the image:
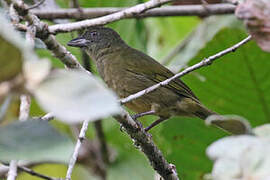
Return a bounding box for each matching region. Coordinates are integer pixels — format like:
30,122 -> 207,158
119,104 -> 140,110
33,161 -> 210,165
49,0 -> 172,34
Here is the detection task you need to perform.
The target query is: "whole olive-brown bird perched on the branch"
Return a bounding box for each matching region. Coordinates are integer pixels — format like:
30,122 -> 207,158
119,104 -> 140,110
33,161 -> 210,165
68,27 -> 243,133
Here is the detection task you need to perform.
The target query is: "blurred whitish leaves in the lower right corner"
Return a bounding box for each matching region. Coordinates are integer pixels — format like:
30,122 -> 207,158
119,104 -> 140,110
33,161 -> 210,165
206,123 -> 270,180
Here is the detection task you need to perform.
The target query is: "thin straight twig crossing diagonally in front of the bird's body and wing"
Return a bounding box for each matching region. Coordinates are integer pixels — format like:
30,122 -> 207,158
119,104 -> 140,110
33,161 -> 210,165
120,36 -> 251,104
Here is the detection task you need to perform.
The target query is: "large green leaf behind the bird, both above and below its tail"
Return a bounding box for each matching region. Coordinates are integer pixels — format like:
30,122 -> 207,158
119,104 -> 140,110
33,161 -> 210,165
150,29 -> 270,180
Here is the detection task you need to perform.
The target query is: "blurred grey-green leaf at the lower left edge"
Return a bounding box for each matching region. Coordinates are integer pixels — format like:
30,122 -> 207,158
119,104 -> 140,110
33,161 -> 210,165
0,120 -> 73,162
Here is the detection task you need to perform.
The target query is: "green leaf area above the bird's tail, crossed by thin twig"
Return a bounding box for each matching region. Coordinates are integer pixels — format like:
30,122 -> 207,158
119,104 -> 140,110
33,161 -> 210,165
185,28 -> 270,126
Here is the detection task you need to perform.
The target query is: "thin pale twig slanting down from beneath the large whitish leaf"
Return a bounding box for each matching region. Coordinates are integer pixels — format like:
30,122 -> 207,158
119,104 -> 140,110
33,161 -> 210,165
66,121 -> 89,180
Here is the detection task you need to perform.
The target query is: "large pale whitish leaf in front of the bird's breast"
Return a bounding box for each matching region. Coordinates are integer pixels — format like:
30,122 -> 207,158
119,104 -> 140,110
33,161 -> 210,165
34,70 -> 120,123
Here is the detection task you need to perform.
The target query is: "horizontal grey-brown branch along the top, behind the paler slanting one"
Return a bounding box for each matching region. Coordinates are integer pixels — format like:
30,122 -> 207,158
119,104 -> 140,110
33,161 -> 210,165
31,4 -> 235,20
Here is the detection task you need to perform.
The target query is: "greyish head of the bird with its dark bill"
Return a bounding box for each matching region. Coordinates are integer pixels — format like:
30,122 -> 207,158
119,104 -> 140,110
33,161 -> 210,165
67,26 -> 124,57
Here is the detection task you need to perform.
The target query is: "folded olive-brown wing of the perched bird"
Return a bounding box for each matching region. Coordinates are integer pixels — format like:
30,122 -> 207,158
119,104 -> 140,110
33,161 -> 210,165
124,48 -> 199,102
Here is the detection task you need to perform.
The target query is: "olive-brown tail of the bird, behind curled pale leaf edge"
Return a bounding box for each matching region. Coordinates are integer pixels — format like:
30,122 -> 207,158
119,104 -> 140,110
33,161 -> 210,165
193,103 -> 247,134
